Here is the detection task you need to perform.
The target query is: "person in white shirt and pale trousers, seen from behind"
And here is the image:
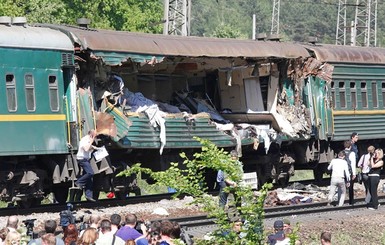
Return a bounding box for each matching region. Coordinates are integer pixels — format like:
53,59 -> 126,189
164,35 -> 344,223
328,151 -> 350,206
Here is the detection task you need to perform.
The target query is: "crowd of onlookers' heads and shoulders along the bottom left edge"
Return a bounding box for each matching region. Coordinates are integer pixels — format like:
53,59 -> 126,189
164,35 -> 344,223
0,213 -> 183,245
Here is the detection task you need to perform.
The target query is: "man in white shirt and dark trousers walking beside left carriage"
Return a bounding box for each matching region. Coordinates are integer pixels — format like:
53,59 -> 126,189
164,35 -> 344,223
75,130 -> 98,202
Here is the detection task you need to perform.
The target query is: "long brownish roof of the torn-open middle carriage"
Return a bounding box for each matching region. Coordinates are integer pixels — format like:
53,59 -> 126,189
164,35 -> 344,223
42,25 -> 309,58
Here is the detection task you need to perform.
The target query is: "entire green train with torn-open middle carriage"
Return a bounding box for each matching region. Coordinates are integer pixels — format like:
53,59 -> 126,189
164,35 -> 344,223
0,17 -> 385,206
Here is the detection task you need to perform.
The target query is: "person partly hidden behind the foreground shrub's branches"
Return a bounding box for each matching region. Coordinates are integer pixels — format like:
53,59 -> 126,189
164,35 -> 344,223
217,150 -> 243,209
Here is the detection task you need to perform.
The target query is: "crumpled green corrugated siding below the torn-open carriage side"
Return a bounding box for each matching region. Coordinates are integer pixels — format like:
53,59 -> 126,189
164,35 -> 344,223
119,117 -> 236,149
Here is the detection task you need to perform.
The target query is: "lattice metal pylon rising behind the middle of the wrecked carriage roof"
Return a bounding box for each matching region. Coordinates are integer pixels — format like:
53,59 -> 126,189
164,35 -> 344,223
163,0 -> 191,36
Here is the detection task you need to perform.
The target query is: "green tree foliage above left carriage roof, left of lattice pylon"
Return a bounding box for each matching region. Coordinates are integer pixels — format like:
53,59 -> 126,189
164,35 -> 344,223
0,0 -> 163,33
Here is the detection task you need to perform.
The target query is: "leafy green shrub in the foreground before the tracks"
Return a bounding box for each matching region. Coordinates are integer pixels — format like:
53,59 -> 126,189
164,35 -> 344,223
119,139 -> 271,245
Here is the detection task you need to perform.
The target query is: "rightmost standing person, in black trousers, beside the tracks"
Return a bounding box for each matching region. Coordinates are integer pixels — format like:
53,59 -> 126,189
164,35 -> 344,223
368,149 -> 384,210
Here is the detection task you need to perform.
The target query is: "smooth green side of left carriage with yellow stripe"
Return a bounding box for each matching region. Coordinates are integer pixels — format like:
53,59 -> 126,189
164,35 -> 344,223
0,48 -> 68,155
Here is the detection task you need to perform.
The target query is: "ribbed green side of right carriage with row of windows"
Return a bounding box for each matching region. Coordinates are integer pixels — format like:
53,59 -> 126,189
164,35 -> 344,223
331,64 -> 385,141
